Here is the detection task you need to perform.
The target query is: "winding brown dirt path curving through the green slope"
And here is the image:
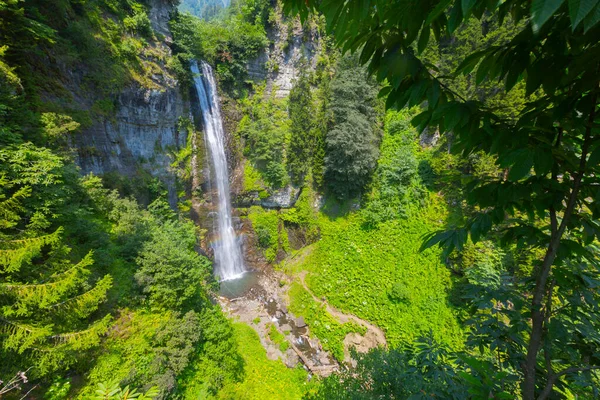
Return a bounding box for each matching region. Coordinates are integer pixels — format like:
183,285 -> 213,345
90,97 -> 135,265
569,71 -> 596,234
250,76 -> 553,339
297,271 -> 387,362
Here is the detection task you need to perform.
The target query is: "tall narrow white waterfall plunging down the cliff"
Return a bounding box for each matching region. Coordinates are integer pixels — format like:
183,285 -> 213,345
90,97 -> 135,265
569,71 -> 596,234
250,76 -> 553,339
192,61 -> 244,280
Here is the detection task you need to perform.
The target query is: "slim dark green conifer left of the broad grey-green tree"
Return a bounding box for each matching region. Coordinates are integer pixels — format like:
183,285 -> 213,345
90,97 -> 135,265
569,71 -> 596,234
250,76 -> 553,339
287,60 -> 315,183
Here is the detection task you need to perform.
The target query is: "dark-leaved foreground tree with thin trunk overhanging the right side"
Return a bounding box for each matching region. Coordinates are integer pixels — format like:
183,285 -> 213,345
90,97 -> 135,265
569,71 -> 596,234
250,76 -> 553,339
286,0 -> 600,400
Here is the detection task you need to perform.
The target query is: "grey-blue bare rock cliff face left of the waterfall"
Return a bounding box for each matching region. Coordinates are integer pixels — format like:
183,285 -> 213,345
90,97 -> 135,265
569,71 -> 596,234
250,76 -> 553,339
75,0 -> 190,204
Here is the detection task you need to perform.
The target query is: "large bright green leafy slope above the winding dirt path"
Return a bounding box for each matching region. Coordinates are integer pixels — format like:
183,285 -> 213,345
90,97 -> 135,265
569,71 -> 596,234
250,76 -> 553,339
290,194 -> 463,346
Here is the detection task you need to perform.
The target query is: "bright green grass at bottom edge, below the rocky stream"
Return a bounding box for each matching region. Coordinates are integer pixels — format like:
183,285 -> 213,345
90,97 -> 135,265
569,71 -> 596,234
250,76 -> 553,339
219,323 -> 314,400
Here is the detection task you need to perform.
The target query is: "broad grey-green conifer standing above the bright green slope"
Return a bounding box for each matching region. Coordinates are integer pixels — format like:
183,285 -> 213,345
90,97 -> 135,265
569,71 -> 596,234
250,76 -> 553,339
325,59 -> 379,199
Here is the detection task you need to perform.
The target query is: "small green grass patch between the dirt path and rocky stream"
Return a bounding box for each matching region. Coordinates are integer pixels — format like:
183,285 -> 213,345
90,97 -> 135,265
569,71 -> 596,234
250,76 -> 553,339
289,282 -> 366,360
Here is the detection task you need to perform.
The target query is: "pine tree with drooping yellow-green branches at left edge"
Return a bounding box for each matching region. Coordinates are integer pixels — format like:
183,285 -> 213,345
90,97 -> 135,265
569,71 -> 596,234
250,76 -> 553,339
0,148 -> 112,377
